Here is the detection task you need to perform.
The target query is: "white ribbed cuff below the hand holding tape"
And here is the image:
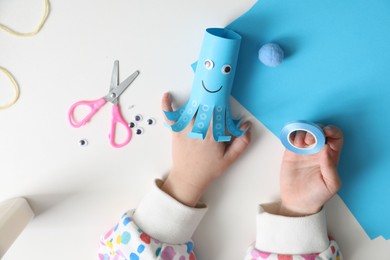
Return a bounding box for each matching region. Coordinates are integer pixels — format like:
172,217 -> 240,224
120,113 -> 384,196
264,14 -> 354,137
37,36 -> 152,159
256,203 -> 329,255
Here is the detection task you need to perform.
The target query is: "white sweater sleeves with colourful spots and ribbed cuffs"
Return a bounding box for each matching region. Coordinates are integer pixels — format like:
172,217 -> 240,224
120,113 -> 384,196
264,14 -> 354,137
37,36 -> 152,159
98,180 -> 342,260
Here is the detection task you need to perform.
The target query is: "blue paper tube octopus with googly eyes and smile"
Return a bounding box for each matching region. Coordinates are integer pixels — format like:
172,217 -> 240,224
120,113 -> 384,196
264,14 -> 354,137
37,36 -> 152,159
165,28 -> 246,142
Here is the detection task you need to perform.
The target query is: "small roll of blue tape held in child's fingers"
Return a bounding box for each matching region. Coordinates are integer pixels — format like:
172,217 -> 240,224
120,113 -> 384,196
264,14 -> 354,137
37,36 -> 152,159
280,121 -> 325,154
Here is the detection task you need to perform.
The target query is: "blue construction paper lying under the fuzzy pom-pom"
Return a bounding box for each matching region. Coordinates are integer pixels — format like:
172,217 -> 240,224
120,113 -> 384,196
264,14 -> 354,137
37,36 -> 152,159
227,0 -> 390,239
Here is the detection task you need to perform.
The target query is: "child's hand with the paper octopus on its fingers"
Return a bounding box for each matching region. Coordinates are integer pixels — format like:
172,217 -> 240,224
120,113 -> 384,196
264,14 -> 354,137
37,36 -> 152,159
161,93 -> 250,207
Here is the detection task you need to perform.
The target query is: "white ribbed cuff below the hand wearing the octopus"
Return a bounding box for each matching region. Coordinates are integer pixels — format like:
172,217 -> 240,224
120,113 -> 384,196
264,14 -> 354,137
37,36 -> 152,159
133,180 -> 207,244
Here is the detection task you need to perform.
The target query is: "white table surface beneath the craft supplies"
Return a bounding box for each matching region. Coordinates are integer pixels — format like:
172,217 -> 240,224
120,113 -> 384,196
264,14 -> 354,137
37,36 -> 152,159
0,0 -> 390,260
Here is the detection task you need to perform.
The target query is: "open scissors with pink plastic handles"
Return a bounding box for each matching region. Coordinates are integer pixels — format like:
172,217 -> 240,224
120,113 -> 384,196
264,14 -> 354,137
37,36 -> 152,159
68,60 -> 139,148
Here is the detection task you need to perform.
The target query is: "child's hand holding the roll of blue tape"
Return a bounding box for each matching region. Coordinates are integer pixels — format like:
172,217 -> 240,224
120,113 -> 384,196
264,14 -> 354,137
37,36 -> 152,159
279,126 -> 343,216
